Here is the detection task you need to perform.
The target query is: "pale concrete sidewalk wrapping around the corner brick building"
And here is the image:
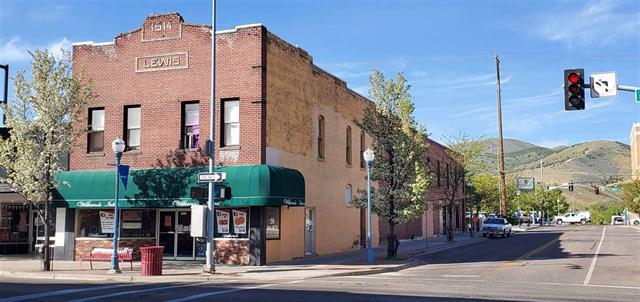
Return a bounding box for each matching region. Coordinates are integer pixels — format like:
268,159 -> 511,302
0,233 -> 483,282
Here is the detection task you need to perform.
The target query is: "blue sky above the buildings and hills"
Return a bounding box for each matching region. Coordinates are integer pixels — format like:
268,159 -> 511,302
0,0 -> 640,147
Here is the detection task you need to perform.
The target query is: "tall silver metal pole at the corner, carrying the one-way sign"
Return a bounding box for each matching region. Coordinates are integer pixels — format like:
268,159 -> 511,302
202,0 -> 216,274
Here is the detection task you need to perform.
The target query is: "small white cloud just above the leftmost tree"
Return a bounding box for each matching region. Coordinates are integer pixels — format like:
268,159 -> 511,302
0,37 -> 71,63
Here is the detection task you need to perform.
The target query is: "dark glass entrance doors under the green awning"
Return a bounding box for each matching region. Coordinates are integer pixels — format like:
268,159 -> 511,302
158,210 -> 195,259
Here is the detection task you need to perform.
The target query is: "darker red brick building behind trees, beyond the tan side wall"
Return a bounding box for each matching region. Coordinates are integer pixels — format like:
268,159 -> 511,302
378,139 -> 466,241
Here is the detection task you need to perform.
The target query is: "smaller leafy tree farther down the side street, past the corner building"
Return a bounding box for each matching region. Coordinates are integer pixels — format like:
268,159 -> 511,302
440,132 -> 486,241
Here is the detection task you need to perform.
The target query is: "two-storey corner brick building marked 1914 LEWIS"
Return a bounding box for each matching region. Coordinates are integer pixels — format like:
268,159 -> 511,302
55,13 -> 377,265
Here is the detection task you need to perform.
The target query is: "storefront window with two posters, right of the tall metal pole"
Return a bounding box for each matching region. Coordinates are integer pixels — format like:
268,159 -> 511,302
215,208 -> 249,238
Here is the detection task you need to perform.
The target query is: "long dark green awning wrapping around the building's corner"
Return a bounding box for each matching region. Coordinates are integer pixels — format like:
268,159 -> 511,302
54,165 -> 304,208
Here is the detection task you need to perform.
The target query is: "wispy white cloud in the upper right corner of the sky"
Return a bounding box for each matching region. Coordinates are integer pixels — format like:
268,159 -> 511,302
531,0 -> 640,47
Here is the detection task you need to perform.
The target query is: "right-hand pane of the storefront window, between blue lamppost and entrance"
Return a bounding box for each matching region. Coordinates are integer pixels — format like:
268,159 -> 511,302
120,210 -> 156,238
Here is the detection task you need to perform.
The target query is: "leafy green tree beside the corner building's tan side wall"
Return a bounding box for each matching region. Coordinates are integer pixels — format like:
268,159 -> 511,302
354,70 -> 430,258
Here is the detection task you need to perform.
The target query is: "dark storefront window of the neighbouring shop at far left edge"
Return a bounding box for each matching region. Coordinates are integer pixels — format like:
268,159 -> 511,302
0,204 -> 29,244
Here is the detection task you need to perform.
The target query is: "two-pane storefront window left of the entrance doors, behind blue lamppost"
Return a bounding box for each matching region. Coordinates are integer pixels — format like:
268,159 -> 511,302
77,209 -> 156,238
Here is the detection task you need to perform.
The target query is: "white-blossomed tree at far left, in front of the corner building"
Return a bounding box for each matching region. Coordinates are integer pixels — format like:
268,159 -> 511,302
0,50 -> 93,270
